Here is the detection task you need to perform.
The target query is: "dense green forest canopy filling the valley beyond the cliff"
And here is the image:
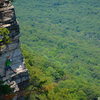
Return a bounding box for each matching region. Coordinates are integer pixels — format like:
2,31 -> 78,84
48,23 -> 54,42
14,0 -> 100,100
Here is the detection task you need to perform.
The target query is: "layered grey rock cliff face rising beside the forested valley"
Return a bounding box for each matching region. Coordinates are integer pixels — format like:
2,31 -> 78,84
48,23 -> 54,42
0,0 -> 29,91
